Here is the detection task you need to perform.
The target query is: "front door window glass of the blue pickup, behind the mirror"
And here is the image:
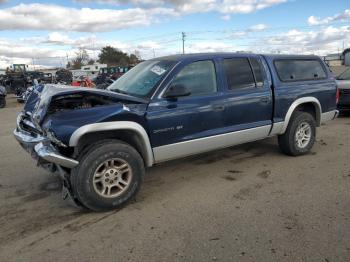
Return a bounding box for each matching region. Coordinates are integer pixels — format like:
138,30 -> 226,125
171,60 -> 217,96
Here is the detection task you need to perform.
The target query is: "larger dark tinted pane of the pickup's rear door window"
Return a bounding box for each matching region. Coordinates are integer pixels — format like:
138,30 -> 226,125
223,58 -> 255,90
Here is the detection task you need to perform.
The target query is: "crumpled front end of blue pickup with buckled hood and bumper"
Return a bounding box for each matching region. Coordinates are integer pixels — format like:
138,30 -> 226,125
14,85 -> 147,205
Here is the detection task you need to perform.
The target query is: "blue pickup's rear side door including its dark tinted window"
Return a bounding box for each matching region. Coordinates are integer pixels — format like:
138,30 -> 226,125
221,56 -> 273,133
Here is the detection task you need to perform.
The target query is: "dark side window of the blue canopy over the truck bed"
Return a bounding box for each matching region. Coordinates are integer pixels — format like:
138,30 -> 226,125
275,59 -> 326,82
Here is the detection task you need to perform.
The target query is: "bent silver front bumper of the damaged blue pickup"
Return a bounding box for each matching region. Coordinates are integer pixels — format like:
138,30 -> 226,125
13,116 -> 79,169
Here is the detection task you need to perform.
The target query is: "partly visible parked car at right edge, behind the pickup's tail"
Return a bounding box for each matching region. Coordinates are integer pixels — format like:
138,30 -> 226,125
337,68 -> 350,112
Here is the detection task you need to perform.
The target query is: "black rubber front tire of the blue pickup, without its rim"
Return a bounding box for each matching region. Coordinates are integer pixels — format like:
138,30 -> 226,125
70,140 -> 145,211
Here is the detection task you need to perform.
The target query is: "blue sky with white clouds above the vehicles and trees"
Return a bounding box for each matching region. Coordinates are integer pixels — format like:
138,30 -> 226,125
0,0 -> 350,68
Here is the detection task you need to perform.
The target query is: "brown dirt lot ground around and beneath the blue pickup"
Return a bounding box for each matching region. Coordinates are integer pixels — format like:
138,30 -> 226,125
0,95 -> 350,262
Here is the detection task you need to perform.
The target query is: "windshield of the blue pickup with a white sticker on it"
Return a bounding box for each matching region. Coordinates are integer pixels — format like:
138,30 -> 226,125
108,60 -> 175,98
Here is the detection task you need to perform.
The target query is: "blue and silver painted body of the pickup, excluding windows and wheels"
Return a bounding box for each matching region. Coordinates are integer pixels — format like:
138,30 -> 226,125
14,53 -> 337,169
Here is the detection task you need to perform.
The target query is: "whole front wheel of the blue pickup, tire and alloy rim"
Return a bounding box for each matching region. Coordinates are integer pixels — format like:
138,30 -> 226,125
71,141 -> 145,211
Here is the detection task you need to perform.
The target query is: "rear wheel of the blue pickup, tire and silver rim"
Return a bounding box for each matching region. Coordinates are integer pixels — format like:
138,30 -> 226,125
278,111 -> 316,156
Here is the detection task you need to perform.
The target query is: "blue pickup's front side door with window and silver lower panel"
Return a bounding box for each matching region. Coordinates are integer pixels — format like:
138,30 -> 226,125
147,60 -> 224,162
